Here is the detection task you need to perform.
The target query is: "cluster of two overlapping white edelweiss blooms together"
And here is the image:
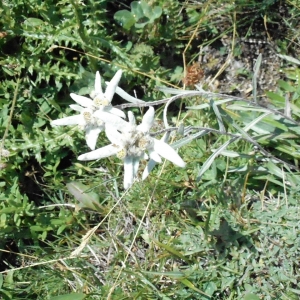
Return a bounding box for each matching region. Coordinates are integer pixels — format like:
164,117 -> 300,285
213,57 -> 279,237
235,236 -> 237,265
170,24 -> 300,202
51,70 -> 185,189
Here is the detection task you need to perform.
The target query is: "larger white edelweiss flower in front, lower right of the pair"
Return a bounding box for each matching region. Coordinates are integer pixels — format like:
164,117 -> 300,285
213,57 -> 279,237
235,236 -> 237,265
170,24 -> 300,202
78,107 -> 185,189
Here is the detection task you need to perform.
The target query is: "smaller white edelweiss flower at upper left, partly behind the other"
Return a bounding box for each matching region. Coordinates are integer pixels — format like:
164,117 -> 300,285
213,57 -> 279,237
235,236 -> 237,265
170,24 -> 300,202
51,70 -> 125,150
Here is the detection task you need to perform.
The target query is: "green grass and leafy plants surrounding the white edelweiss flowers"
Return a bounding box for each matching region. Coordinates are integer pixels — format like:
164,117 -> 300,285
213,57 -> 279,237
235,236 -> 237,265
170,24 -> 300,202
0,0 -> 300,300
